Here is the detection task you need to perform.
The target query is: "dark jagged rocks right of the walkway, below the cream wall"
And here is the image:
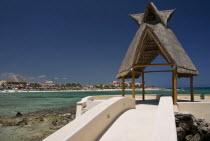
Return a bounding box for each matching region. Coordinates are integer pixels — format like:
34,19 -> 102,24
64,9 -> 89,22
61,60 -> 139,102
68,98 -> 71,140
175,113 -> 210,141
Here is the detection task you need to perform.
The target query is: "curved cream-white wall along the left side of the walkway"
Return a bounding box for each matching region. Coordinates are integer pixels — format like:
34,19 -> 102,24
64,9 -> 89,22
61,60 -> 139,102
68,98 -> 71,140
44,97 -> 136,141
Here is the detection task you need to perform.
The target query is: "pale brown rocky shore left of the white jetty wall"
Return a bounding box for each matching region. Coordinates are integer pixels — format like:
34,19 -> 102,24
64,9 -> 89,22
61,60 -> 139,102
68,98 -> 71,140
0,113 -> 75,141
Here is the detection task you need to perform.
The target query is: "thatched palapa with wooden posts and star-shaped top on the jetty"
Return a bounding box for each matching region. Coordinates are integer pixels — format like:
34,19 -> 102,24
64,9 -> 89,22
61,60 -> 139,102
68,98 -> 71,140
117,2 -> 198,104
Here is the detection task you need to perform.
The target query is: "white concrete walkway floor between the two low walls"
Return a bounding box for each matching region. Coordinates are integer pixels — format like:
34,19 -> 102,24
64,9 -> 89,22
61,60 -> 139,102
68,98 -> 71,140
100,102 -> 158,141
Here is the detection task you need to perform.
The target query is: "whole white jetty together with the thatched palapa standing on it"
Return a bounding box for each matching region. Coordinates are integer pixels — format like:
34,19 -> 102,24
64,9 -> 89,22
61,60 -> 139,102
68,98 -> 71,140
44,2 -> 210,141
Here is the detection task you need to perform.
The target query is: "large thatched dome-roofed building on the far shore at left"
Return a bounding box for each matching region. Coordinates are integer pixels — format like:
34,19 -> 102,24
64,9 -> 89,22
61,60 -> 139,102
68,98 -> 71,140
6,75 -> 27,89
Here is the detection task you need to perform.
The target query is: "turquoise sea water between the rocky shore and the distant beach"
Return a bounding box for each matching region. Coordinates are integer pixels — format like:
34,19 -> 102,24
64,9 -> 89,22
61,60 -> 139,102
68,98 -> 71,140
0,88 -> 210,117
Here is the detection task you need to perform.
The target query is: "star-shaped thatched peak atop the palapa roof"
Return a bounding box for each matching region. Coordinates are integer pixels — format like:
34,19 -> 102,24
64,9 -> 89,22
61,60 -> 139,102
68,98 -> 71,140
130,2 -> 175,27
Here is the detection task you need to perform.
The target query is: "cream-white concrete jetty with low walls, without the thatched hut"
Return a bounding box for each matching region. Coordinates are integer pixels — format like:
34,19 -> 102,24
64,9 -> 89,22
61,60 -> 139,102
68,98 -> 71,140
44,95 -> 210,141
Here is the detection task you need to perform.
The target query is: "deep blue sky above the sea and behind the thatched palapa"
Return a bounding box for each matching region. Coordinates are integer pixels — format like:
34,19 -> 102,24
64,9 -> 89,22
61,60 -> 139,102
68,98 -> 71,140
0,0 -> 210,87
